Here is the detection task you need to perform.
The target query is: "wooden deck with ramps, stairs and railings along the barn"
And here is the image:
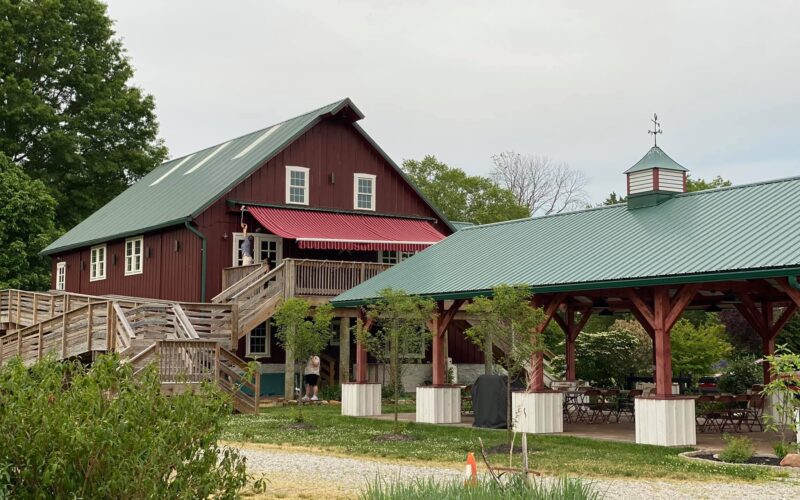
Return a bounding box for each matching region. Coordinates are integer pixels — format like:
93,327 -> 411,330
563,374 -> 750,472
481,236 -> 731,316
0,259 -> 390,412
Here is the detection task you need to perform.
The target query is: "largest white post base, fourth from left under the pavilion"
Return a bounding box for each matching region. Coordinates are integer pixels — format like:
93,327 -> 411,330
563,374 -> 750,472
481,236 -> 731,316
634,398 -> 697,446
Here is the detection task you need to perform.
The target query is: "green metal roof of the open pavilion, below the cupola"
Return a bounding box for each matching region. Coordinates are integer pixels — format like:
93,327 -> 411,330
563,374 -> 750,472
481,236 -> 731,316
332,177 -> 800,306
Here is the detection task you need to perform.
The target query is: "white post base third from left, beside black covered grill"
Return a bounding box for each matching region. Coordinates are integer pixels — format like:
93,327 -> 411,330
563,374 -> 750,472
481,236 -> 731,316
511,392 -> 564,434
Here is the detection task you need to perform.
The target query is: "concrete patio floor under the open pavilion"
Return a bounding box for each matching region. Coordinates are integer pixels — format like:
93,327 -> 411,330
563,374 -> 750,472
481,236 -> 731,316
368,413 -> 780,454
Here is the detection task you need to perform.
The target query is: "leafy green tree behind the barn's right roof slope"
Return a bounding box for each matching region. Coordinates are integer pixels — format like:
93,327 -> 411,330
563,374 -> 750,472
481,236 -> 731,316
403,155 -> 530,224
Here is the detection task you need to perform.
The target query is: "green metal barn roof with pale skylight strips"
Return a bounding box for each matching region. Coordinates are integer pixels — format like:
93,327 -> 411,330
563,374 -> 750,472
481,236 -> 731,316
42,99 -> 452,254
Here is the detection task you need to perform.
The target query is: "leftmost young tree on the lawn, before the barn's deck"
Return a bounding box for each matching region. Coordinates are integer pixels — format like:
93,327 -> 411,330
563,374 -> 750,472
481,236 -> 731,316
274,298 -> 333,422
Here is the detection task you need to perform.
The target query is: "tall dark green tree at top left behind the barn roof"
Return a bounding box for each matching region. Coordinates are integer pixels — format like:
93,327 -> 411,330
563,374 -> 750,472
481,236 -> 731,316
0,0 -> 166,228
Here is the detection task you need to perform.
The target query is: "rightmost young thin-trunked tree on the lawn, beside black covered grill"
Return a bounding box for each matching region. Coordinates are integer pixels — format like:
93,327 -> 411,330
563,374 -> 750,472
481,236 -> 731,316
465,285 -> 544,446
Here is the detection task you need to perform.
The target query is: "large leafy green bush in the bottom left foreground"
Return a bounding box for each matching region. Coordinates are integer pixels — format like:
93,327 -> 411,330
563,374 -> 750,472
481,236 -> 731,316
0,356 -> 247,499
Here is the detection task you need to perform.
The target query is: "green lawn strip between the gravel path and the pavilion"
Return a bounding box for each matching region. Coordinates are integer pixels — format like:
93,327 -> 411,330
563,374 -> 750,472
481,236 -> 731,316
223,406 -> 777,481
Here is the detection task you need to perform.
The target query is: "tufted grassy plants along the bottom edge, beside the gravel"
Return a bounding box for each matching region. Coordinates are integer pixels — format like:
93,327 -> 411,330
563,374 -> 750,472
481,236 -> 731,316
359,475 -> 602,500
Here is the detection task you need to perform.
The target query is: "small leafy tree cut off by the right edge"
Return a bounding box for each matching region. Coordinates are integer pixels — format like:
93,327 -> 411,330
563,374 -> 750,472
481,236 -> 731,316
761,346 -> 800,458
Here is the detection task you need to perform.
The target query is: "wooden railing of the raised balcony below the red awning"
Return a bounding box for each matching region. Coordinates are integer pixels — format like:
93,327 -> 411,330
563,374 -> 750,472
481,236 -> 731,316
290,259 -> 391,297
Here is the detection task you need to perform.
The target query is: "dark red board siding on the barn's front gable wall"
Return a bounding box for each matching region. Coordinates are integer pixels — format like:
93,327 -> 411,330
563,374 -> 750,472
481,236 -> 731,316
196,118 -> 449,297
